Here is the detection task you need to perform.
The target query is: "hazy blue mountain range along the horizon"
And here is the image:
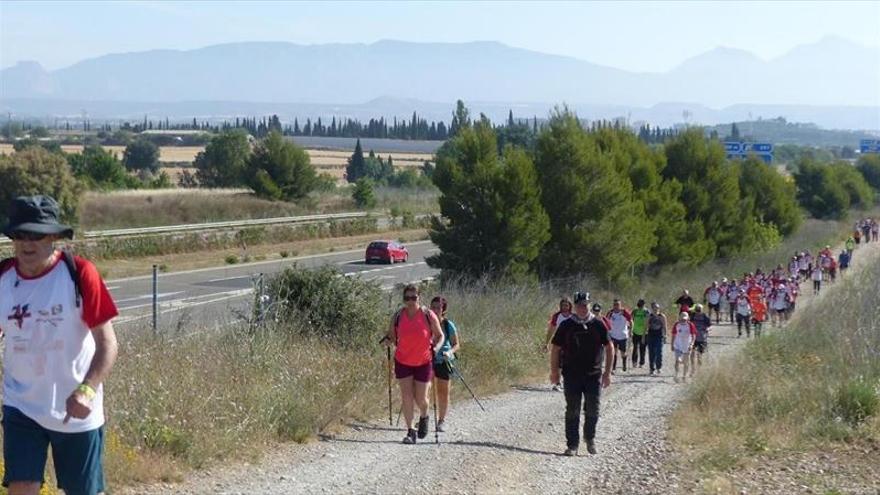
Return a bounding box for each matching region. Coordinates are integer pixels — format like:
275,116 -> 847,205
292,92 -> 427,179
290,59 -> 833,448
0,37 -> 880,129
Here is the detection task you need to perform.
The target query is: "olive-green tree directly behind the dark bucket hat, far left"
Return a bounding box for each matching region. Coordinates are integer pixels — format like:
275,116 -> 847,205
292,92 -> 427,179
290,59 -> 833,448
0,147 -> 82,229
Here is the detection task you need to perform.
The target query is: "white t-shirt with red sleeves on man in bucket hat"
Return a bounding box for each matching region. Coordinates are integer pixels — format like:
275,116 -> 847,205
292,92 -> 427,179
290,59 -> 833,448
0,255 -> 118,433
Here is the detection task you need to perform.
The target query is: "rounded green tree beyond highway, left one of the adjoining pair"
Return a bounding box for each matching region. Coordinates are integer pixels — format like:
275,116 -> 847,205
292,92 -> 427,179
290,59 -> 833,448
193,129 -> 251,187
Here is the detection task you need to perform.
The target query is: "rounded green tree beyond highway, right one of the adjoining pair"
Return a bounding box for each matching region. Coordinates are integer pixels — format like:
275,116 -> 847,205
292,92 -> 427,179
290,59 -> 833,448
247,131 -> 317,201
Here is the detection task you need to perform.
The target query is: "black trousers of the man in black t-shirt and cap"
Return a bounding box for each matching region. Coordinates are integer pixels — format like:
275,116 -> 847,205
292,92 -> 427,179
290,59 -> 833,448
563,374 -> 602,449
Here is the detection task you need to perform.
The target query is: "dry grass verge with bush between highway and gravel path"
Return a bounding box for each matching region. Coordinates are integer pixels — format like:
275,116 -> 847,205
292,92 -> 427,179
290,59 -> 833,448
55,213 -> 849,484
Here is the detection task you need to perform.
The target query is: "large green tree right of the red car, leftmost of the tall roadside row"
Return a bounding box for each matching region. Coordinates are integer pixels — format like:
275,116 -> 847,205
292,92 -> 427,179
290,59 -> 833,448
428,124 -> 550,280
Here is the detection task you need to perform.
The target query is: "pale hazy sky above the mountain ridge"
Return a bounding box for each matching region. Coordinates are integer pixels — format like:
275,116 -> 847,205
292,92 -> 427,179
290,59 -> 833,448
0,0 -> 880,71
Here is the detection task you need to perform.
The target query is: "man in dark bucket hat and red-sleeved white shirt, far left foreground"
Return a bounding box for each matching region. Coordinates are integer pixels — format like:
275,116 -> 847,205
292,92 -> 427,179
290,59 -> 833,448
0,196 -> 119,494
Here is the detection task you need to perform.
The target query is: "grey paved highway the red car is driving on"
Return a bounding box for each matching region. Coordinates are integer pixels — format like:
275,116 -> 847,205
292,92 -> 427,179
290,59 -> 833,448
107,241 -> 437,330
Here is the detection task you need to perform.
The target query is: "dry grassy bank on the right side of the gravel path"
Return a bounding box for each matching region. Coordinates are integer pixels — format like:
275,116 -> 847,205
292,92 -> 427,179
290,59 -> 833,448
672,239 -> 880,493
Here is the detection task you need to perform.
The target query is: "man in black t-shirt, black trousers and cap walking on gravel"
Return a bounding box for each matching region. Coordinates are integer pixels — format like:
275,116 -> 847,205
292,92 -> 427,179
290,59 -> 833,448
550,292 -> 614,456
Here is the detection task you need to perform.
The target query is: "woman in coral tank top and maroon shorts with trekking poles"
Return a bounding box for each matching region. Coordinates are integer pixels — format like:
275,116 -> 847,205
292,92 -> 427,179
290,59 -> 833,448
385,284 -> 443,444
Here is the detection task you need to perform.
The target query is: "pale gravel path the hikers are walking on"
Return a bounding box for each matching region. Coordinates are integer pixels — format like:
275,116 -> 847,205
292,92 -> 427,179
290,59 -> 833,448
126,244 -> 880,494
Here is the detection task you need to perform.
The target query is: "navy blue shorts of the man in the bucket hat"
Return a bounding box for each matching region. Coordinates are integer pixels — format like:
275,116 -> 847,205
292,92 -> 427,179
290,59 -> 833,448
3,406 -> 104,495
